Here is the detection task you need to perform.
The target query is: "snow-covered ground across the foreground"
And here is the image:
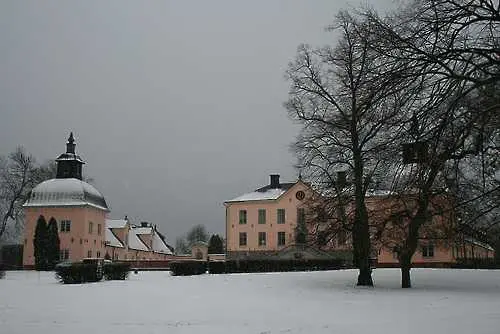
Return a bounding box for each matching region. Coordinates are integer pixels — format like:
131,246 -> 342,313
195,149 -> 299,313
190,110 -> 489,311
0,269 -> 500,334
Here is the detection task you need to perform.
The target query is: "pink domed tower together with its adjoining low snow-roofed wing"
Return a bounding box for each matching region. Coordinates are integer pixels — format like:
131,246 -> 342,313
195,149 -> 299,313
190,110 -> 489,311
23,133 -> 172,268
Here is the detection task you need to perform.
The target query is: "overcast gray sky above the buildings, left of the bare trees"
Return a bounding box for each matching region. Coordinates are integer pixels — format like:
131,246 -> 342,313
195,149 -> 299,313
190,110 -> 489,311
0,0 -> 391,244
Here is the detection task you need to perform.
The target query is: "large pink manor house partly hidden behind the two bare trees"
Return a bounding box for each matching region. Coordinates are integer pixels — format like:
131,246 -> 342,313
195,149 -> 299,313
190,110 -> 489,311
224,174 -> 494,266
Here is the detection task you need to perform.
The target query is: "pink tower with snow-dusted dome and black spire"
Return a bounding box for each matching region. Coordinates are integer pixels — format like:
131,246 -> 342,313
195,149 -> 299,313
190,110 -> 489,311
23,133 -> 109,268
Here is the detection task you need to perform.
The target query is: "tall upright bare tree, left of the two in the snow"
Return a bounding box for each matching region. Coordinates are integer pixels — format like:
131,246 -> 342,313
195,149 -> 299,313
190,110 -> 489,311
285,12 -> 409,285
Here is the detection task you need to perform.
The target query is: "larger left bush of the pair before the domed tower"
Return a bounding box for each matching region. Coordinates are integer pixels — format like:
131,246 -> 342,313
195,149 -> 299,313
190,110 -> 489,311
55,262 -> 102,284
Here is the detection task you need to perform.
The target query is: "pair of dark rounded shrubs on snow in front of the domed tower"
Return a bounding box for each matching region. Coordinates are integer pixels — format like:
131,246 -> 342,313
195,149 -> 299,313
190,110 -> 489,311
55,262 -> 130,284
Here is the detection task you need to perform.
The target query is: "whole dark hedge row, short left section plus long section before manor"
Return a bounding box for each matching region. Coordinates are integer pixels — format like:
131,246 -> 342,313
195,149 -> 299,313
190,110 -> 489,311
170,259 -> 346,276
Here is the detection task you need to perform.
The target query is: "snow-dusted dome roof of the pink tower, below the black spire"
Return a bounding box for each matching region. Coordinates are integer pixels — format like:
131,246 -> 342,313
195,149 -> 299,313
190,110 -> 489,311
24,178 -> 109,211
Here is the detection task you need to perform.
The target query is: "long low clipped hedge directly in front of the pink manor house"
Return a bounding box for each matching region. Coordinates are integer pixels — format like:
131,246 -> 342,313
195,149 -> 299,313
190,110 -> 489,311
208,259 -> 346,274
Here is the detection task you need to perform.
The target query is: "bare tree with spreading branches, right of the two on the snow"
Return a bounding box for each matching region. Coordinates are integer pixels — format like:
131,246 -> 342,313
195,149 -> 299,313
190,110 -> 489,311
364,0 -> 500,287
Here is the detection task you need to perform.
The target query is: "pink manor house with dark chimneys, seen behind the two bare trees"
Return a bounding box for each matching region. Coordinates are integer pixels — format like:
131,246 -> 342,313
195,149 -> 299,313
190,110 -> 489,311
224,175 -> 494,267
